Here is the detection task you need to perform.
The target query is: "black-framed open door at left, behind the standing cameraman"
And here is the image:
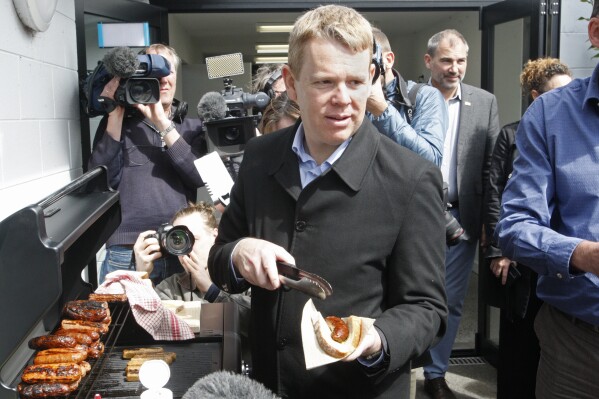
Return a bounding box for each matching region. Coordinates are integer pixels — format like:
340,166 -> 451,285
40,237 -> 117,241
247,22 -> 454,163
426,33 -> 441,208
75,0 -> 168,172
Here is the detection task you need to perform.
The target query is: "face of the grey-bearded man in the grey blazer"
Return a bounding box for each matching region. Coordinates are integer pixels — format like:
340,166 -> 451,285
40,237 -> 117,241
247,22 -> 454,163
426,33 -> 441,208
424,39 -> 468,94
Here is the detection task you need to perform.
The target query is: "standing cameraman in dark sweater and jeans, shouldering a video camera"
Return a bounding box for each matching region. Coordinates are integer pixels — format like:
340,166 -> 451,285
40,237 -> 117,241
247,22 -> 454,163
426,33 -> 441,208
88,44 -> 206,283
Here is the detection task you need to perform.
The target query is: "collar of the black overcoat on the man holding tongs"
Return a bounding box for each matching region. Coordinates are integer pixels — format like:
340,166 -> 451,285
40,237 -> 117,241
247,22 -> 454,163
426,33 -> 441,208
269,118 -> 380,198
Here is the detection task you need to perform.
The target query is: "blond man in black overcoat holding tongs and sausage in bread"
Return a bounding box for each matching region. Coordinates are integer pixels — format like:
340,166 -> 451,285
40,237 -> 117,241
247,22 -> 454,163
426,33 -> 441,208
208,5 -> 447,398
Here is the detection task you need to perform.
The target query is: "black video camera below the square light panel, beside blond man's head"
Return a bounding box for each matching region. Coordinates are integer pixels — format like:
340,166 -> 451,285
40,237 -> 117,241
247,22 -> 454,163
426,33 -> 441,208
204,78 -> 270,156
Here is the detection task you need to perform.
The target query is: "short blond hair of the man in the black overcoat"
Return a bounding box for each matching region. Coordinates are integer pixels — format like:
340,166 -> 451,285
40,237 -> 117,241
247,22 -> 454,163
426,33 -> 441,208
288,4 -> 373,76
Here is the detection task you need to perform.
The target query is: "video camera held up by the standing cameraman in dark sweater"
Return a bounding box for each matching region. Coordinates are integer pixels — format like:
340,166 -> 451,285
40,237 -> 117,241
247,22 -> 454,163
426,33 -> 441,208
82,47 -> 171,117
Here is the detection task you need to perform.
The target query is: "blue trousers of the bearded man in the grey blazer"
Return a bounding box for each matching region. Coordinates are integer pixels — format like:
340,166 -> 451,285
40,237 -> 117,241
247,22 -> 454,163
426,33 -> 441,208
424,209 -> 478,379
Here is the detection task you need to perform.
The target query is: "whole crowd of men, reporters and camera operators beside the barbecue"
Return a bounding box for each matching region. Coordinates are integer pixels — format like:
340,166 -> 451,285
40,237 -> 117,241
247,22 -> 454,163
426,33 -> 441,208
89,2 -> 599,399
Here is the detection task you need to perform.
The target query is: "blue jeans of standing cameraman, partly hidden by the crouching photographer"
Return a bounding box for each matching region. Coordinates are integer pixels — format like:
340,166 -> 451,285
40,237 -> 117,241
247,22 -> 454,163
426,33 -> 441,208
99,245 -> 185,286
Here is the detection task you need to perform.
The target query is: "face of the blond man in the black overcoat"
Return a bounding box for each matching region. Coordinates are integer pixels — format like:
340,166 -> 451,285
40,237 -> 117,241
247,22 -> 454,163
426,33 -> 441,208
284,39 -> 374,163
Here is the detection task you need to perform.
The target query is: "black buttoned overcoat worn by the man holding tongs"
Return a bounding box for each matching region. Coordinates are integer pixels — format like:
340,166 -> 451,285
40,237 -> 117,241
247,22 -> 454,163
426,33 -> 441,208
209,118 -> 447,398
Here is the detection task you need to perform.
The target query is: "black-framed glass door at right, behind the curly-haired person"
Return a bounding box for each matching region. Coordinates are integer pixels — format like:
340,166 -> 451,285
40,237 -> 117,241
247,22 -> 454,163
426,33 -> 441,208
477,0 -> 560,365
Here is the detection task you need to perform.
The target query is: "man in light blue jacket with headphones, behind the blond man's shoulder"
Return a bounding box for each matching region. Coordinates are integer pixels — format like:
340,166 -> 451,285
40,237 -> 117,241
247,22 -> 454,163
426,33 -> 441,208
366,28 -> 448,166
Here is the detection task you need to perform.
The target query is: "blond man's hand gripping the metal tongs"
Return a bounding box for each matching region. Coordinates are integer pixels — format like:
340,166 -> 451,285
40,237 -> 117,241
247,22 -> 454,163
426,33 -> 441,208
232,238 -> 295,290
